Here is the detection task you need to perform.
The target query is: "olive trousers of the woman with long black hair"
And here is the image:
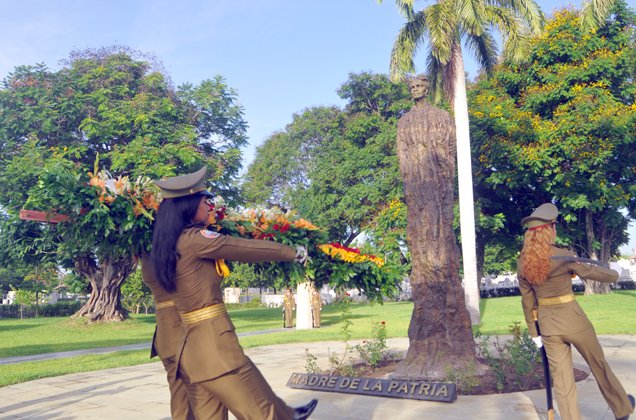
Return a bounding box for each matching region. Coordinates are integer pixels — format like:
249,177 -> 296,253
180,357 -> 294,420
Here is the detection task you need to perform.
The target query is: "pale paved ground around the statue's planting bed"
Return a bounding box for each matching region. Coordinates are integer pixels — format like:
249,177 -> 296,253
0,335 -> 636,420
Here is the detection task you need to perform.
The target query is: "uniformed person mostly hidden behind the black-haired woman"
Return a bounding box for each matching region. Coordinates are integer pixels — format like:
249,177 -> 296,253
141,254 -> 216,420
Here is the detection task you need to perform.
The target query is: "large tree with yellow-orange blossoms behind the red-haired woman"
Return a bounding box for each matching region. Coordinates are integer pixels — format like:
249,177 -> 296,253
471,1 -> 636,293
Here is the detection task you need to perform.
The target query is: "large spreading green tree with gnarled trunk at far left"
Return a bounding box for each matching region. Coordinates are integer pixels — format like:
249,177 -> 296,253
0,47 -> 246,320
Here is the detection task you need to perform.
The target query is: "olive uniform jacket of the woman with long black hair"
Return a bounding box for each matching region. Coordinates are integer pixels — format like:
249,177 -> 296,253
172,226 -> 295,383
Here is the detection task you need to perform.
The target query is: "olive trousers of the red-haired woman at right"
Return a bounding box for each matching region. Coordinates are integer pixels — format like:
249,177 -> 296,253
542,327 -> 632,420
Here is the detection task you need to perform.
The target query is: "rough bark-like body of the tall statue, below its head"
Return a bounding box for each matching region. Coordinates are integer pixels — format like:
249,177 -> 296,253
393,95 -> 477,379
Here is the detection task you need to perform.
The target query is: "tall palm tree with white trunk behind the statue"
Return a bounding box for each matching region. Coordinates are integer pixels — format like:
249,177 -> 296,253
379,0 -> 544,324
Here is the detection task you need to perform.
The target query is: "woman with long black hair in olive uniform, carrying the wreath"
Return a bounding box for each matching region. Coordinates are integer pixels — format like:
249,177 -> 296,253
151,168 -> 317,419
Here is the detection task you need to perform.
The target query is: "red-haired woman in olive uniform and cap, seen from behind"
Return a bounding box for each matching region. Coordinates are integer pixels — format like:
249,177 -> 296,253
517,203 -> 634,420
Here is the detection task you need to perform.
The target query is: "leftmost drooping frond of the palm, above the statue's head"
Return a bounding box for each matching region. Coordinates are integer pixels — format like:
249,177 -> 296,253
390,12 -> 427,81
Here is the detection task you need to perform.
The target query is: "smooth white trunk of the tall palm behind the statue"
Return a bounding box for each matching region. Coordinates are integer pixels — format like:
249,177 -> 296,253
452,43 -> 481,325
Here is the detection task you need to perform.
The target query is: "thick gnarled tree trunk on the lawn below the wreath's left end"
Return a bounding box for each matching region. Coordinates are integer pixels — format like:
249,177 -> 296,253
73,256 -> 136,322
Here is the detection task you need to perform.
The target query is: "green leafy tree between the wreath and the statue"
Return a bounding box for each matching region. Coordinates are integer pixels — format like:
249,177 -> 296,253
243,73 -> 411,249
